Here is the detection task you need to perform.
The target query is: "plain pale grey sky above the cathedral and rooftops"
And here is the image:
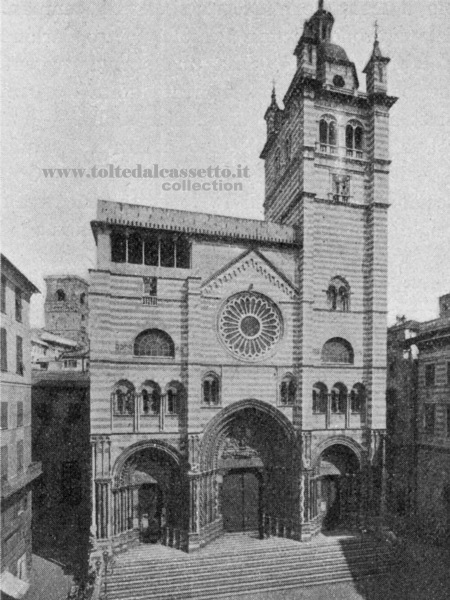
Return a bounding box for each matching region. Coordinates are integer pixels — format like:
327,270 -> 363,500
2,0 -> 450,326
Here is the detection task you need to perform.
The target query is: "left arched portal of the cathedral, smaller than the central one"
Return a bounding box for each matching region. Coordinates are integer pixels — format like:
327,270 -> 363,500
112,441 -> 189,542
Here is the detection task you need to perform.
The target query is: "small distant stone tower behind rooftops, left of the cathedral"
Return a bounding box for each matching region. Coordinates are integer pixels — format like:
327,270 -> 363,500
44,275 -> 89,344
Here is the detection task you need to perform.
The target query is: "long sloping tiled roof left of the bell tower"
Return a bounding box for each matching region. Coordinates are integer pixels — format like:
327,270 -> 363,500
92,200 -> 297,244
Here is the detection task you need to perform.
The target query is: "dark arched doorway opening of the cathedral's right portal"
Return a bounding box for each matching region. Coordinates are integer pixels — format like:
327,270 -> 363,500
319,443 -> 361,530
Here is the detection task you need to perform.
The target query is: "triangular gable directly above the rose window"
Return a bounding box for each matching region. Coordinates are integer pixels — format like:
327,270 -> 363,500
201,249 -> 298,300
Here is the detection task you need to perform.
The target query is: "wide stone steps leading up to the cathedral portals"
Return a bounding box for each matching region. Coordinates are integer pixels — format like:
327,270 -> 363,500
106,534 -> 393,600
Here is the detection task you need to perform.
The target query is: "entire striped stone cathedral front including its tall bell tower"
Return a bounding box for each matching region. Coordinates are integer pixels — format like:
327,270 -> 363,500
89,2 -> 396,551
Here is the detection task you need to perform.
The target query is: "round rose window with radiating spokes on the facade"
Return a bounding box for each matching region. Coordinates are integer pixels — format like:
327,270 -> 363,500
219,292 -> 282,360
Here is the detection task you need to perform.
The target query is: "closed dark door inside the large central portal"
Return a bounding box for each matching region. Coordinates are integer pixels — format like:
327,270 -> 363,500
221,469 -> 262,531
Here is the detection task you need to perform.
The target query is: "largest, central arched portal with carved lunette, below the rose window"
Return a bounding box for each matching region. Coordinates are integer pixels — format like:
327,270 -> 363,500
199,400 -> 299,541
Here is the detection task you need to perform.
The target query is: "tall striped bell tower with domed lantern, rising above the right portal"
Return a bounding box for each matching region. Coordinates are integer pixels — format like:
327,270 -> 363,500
261,1 -> 396,524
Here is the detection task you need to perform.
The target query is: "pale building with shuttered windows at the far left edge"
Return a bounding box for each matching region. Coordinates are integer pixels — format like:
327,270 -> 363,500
0,254 -> 41,598
